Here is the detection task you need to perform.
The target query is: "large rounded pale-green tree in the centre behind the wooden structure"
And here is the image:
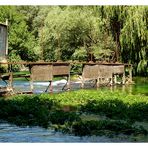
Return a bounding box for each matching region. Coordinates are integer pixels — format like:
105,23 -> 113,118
36,7 -> 112,61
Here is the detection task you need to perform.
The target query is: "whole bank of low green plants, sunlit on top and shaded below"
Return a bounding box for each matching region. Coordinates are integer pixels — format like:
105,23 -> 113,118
0,90 -> 148,140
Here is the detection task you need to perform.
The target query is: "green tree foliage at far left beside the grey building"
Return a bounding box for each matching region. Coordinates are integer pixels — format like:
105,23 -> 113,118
0,6 -> 38,61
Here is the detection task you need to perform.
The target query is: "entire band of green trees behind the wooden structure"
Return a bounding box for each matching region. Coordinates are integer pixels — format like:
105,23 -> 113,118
0,6 -> 148,75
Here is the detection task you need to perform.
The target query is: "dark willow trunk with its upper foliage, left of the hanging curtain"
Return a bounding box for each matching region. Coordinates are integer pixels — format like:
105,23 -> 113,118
98,6 -> 126,62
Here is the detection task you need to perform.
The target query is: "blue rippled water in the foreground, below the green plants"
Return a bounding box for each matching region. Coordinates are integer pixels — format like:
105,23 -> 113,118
0,121 -> 132,143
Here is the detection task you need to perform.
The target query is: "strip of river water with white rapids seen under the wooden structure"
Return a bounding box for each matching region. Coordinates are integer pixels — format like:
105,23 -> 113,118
0,78 -> 148,96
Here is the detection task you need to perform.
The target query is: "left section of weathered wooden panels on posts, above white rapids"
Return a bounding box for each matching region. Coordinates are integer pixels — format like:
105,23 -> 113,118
30,63 -> 70,91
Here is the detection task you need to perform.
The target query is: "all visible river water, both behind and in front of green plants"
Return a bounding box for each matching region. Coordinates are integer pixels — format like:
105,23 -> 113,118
0,80 -> 148,143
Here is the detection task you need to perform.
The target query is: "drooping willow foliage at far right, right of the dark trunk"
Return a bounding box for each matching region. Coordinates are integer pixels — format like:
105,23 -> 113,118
120,6 -> 148,75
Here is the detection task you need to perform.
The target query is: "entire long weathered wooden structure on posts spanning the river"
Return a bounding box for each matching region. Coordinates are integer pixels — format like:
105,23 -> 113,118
0,62 -> 132,95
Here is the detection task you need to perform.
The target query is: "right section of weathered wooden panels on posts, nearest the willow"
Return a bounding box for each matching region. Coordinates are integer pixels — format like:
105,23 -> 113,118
82,63 -> 132,88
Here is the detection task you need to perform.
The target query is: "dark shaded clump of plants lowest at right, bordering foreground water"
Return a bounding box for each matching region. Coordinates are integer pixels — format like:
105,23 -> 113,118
72,120 -> 148,136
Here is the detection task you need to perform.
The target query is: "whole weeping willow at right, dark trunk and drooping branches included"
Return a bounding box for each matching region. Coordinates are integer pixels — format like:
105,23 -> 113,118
98,6 -> 148,75
